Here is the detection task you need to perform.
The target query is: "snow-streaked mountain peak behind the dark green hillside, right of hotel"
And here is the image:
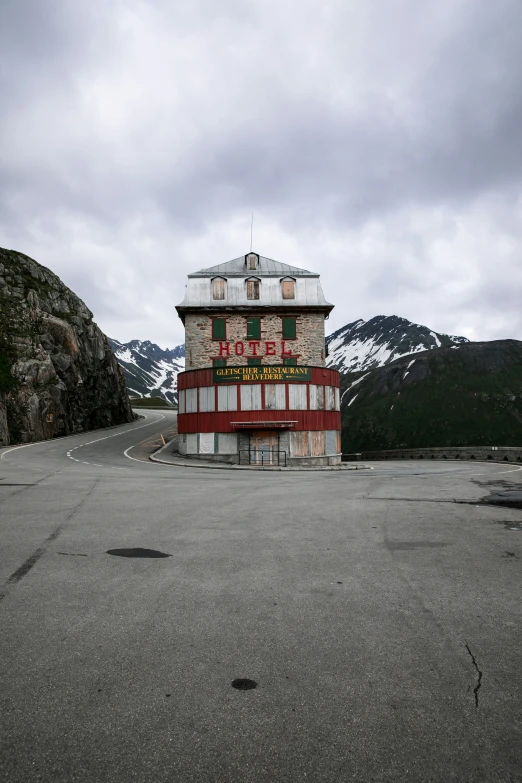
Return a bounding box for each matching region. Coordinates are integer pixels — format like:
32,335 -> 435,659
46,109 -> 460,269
326,315 -> 469,373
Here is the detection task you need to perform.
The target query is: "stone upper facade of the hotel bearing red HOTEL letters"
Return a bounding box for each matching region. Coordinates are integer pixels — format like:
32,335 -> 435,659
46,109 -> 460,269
185,311 -> 325,370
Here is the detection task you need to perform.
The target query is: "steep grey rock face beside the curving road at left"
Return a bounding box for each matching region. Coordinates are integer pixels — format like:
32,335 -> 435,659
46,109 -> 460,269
0,248 -> 134,446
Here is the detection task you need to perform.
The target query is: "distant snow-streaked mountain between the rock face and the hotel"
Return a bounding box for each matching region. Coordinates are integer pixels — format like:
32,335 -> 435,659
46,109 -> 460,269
109,338 -> 185,403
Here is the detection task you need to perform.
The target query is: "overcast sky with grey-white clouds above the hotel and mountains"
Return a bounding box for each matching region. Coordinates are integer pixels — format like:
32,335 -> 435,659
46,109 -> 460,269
0,0 -> 522,347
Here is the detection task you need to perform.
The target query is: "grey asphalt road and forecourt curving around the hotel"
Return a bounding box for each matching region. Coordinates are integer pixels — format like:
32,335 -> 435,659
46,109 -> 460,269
0,412 -> 522,783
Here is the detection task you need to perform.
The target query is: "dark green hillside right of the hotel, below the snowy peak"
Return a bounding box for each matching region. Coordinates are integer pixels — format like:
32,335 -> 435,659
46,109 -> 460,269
341,340 -> 522,453
